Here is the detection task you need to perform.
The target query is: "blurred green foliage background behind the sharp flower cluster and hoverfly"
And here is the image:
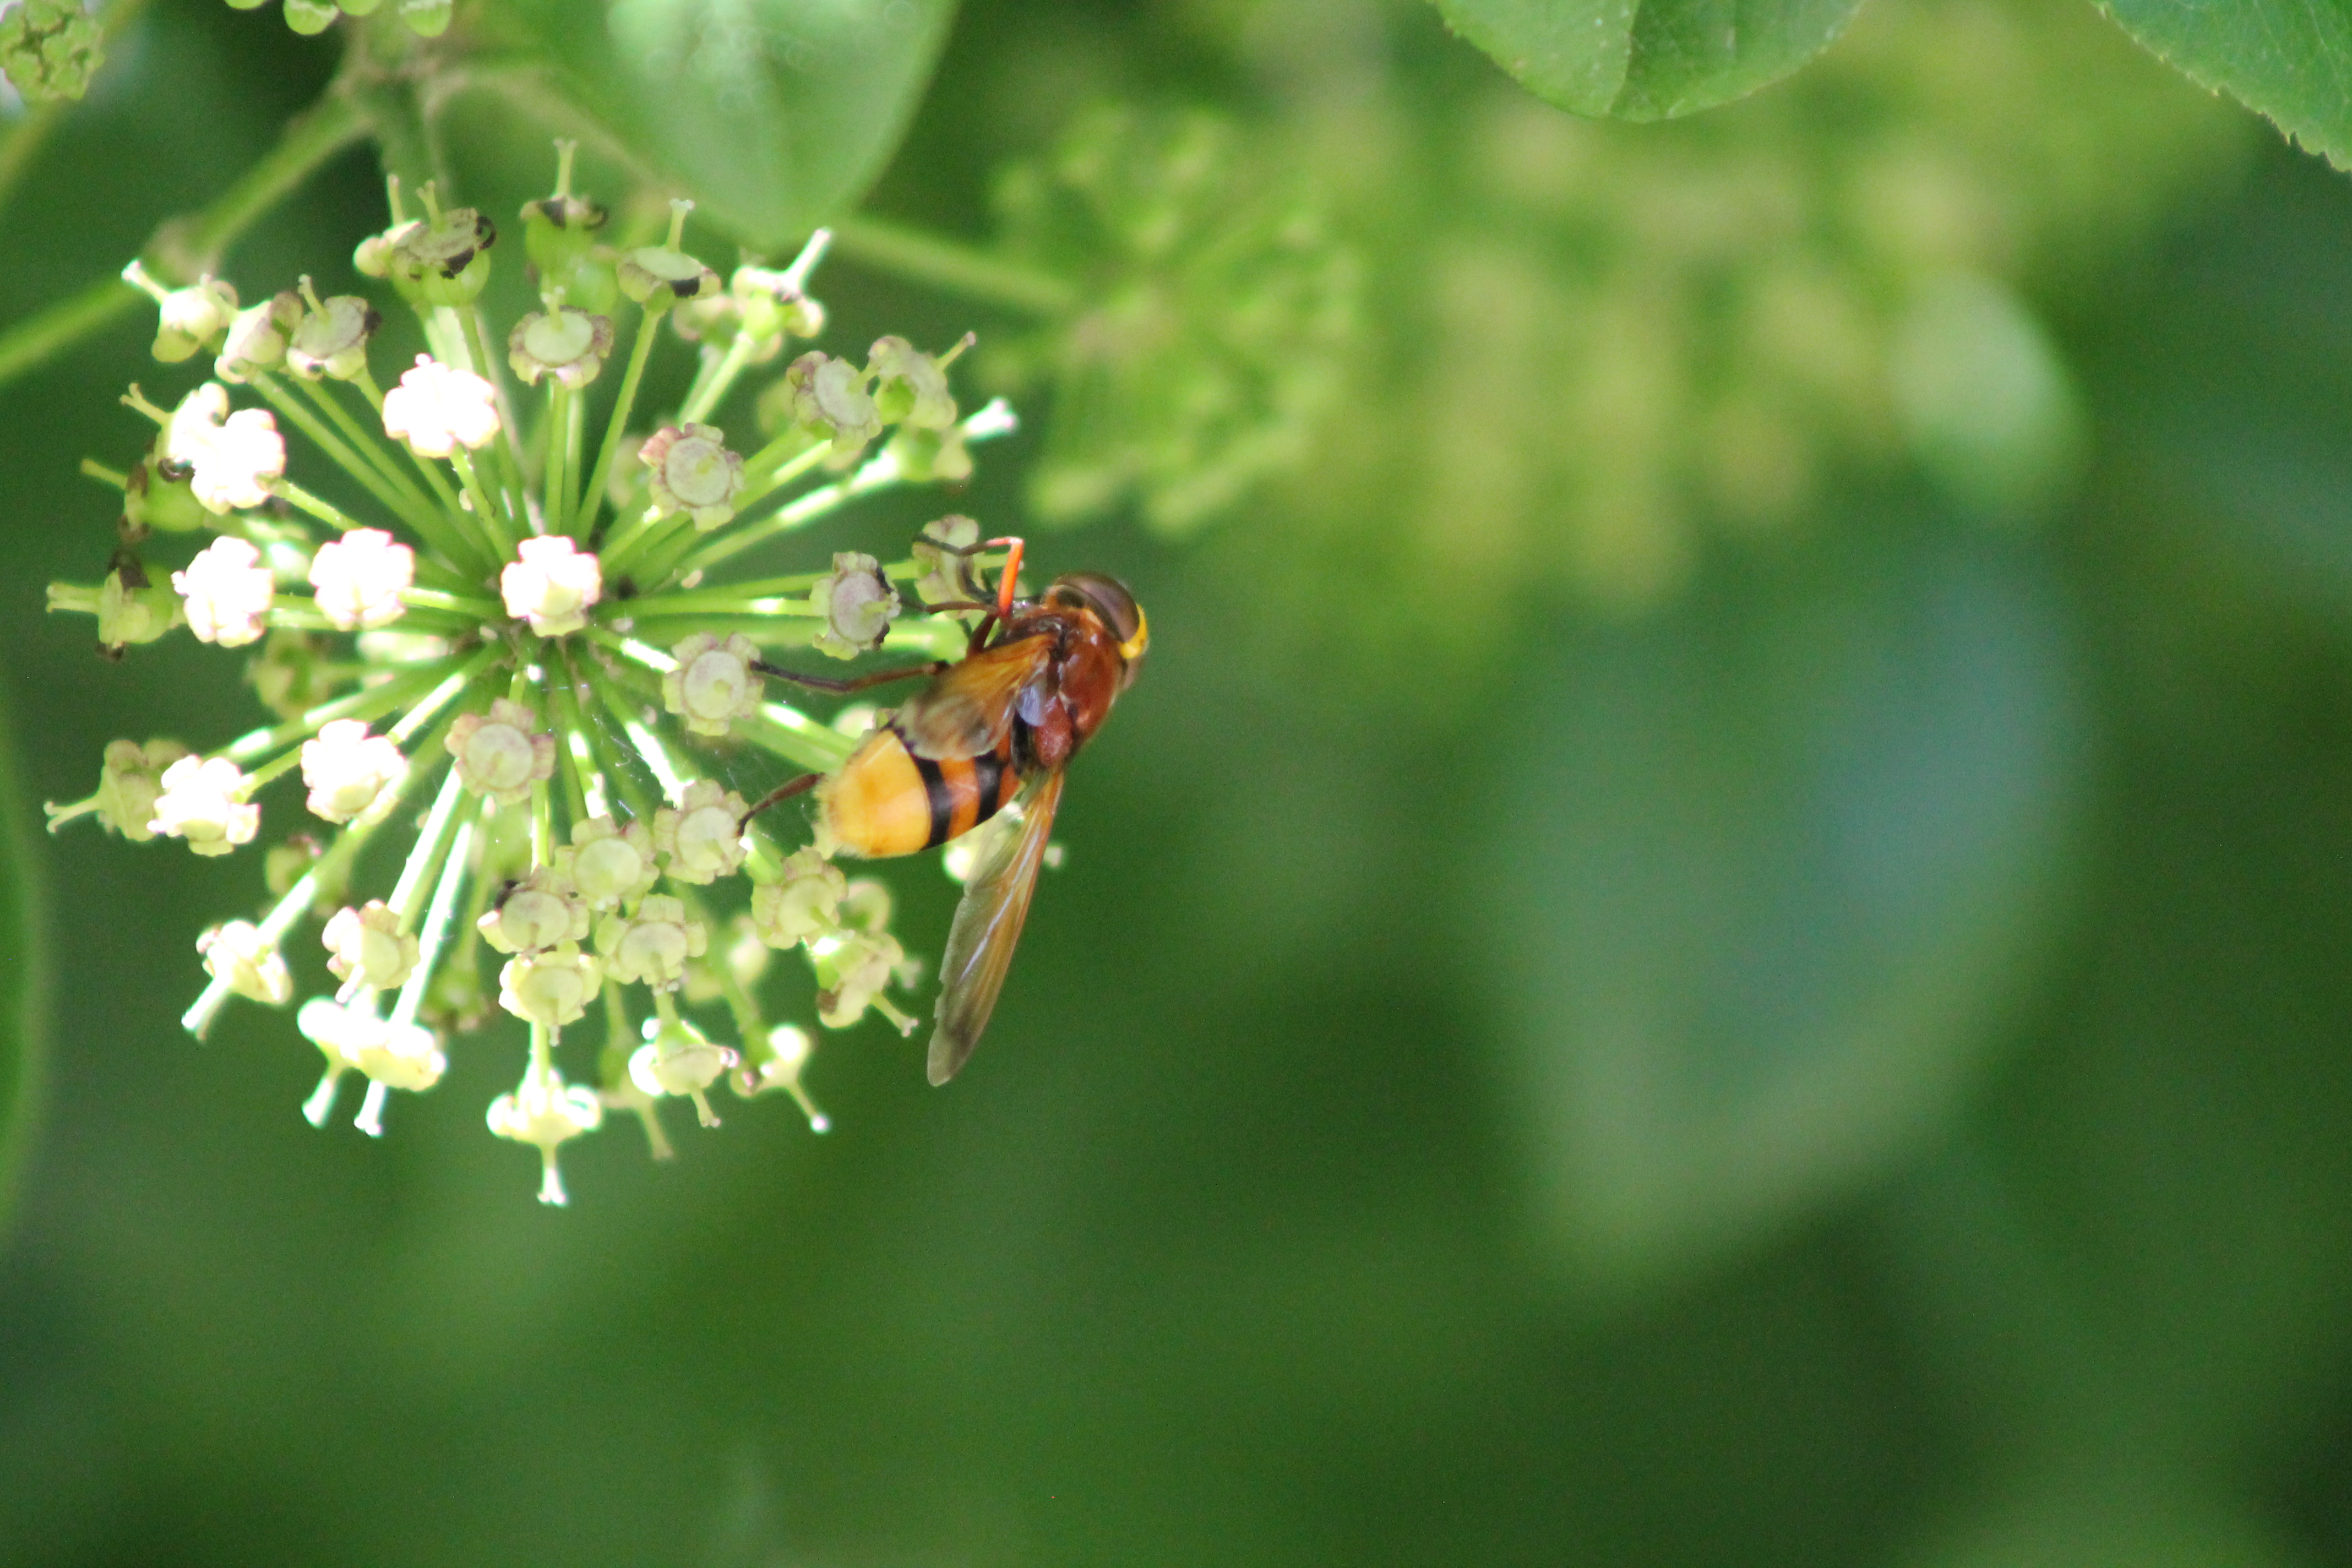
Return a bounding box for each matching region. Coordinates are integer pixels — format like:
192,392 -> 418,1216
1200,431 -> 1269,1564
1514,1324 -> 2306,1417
14,0 -> 2352,1568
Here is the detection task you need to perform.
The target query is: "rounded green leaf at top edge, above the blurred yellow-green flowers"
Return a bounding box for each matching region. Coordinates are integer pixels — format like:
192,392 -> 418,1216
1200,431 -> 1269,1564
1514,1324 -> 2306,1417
1433,0 -> 1860,120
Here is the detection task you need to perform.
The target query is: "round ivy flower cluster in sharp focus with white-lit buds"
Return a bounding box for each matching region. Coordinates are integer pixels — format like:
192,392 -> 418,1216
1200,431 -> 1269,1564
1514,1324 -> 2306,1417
50,144 -> 1011,1204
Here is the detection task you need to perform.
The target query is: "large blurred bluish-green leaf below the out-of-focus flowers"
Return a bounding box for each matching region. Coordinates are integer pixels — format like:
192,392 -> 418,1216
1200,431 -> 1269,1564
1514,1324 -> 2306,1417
1491,526 -> 2082,1279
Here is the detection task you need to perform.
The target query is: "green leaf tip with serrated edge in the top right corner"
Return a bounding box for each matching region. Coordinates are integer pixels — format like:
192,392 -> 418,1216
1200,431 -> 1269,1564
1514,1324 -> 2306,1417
2098,0 -> 2352,169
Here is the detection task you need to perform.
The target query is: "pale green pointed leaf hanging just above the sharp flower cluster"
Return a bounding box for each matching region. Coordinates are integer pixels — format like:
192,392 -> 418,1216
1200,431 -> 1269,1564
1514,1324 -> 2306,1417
518,0 -> 955,247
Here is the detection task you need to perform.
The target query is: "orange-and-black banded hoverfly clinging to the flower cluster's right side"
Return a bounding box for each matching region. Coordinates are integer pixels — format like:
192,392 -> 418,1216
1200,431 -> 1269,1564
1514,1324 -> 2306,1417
743,538 -> 1150,1084
